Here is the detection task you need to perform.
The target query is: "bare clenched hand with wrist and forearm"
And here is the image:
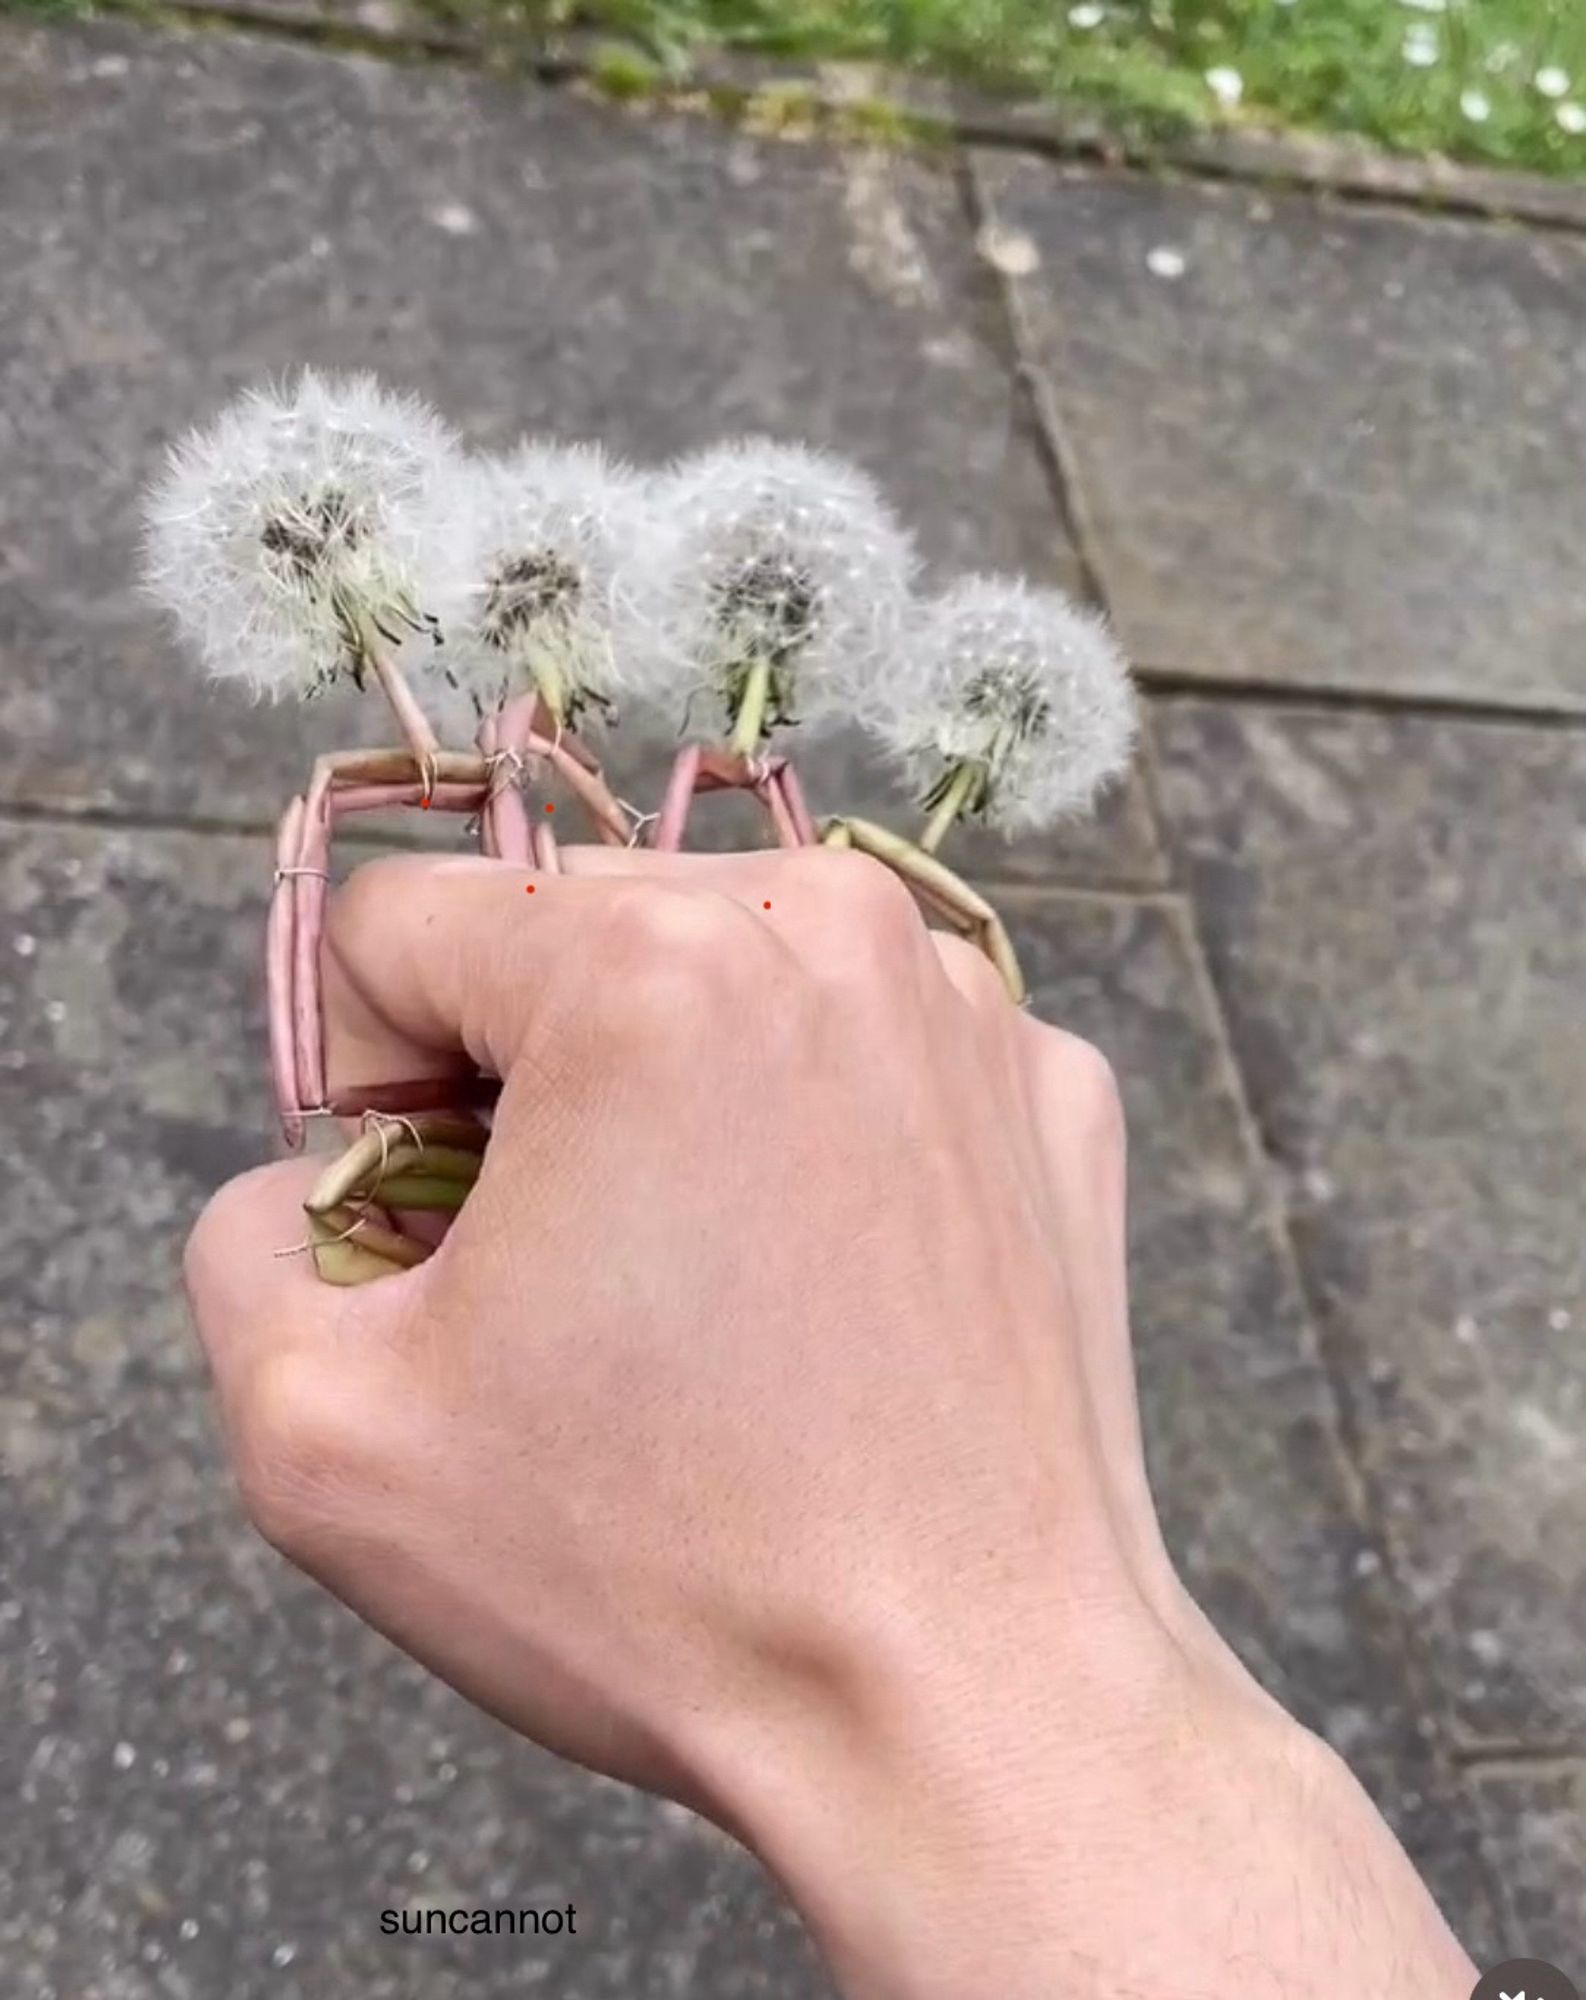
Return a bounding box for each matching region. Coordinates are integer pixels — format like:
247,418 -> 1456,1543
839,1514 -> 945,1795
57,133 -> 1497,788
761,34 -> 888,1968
188,850 -> 1474,2000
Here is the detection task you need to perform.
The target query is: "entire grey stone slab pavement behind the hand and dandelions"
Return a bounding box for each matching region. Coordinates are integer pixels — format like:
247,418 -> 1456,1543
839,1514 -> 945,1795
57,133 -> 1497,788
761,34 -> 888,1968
0,11 -> 1586,2000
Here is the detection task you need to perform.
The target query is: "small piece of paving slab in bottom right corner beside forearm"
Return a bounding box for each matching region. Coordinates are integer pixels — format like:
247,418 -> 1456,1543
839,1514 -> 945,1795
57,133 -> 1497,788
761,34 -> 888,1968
1476,1764 -> 1586,1986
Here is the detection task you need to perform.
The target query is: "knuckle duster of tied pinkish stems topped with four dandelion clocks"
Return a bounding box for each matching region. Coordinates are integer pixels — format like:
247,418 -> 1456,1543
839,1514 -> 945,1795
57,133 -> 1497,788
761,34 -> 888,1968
144,370 -> 1136,1284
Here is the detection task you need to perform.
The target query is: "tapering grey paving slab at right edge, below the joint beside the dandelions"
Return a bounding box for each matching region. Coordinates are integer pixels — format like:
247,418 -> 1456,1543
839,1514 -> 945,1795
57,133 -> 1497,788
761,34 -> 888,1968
1154,700 -> 1586,1754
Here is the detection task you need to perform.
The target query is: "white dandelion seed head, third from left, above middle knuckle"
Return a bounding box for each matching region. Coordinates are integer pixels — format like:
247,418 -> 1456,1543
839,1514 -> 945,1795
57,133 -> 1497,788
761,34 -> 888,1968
630,438 -> 914,744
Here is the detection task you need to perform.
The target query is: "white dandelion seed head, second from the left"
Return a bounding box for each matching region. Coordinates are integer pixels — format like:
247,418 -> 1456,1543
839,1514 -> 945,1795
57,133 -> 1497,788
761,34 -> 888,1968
428,444 -> 646,724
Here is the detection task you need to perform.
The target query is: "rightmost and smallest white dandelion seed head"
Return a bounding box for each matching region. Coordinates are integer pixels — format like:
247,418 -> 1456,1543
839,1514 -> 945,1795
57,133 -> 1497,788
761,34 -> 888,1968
866,576 -> 1136,834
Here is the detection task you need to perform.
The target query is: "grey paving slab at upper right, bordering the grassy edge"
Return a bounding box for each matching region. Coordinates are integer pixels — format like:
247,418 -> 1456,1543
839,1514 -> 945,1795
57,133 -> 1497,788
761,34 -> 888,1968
976,154 -> 1586,710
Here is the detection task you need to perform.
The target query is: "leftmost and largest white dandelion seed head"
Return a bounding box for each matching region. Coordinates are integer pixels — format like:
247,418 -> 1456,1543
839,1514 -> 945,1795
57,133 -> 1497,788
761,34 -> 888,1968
144,370 -> 456,694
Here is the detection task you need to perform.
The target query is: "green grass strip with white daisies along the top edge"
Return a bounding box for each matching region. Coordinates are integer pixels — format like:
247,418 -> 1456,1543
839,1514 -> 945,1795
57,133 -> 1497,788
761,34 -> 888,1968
428,0 -> 1586,174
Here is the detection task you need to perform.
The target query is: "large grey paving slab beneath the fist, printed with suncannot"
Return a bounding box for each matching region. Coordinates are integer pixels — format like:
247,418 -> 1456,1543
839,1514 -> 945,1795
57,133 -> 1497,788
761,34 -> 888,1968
0,822 -> 1494,1968
